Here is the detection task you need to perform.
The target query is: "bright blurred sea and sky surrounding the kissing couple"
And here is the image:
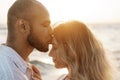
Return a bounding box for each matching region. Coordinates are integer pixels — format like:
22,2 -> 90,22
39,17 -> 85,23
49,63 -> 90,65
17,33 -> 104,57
0,0 -> 120,80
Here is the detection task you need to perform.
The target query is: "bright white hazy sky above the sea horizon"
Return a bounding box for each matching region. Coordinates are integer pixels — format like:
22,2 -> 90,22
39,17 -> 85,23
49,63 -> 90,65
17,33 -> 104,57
0,0 -> 120,24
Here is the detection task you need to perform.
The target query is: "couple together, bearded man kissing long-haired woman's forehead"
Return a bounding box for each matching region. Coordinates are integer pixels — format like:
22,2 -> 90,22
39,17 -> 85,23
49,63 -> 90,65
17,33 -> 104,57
0,0 -> 112,80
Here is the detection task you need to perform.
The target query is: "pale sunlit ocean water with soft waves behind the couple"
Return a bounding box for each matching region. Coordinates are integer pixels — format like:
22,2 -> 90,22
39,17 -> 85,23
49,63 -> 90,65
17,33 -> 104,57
0,24 -> 120,80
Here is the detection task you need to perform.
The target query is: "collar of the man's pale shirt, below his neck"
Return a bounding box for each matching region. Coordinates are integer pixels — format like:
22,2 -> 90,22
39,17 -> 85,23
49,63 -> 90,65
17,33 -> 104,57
2,45 -> 27,73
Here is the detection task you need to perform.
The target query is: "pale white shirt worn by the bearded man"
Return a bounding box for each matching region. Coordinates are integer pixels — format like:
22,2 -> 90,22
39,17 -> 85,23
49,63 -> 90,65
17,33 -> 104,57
0,45 -> 29,80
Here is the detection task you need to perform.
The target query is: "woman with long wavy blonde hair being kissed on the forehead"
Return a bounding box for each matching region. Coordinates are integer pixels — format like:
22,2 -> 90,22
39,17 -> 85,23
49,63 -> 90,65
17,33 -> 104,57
49,21 -> 112,80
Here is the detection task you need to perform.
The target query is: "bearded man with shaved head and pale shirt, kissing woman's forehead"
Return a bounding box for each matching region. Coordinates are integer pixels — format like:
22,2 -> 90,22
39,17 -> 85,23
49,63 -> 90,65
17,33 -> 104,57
0,0 -> 52,80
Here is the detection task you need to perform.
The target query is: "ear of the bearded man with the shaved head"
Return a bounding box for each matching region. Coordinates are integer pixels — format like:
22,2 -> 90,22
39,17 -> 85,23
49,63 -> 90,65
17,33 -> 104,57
17,19 -> 30,33
